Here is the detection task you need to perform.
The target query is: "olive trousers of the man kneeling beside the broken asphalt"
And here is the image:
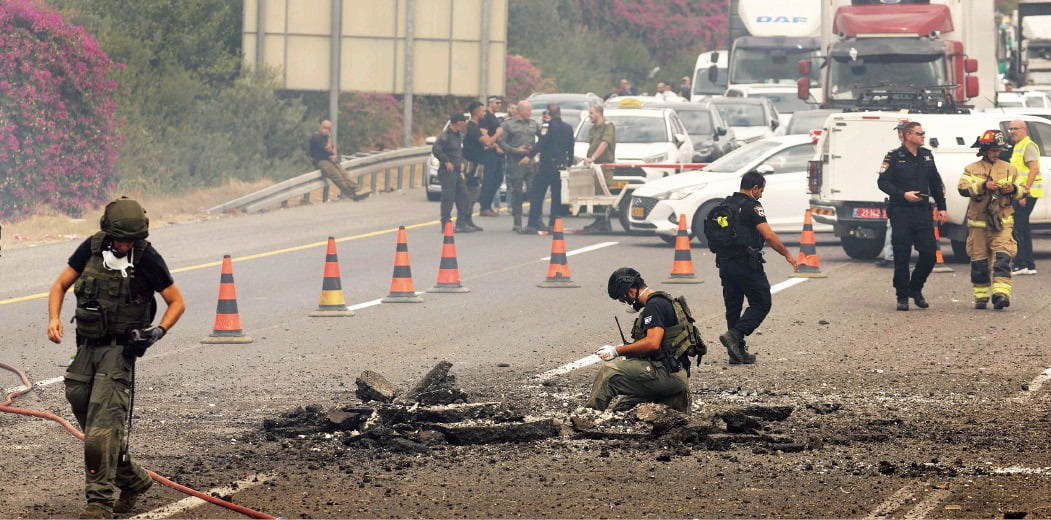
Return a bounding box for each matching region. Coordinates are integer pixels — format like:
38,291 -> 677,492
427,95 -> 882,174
584,357 -> 689,413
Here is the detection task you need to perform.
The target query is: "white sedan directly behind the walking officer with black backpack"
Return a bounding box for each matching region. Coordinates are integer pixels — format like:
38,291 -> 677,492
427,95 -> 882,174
630,136 -> 831,245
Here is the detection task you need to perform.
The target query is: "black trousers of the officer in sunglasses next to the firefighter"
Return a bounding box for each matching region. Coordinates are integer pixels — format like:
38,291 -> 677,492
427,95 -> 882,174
887,205 -> 937,298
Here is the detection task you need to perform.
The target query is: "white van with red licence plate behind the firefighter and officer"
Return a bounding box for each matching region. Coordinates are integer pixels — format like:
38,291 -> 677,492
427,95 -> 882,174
807,112 -> 1051,258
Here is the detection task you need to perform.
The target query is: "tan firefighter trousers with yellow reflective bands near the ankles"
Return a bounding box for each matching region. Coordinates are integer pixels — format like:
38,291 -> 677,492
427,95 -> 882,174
967,222 -> 1018,301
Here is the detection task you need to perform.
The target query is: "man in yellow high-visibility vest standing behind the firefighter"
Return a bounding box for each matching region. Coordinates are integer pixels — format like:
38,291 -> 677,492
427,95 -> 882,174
1008,120 -> 1044,274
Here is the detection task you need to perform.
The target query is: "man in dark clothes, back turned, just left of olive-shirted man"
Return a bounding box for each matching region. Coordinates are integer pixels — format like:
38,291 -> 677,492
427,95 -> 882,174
522,105 -> 573,234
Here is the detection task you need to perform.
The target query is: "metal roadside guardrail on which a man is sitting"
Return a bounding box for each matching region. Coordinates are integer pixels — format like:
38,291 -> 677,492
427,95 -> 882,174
208,146 -> 431,213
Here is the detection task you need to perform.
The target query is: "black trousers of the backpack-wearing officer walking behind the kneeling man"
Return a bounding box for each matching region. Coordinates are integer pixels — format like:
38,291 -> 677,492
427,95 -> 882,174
719,257 -> 774,336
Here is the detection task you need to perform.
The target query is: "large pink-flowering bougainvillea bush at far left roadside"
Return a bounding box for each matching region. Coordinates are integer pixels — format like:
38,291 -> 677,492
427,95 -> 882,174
0,0 -> 121,219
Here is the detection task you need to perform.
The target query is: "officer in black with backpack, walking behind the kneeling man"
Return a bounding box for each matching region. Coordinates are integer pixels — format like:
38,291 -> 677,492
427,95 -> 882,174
705,171 -> 798,365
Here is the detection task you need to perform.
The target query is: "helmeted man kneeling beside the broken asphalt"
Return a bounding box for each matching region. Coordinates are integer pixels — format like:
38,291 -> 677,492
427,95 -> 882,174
585,267 -> 705,413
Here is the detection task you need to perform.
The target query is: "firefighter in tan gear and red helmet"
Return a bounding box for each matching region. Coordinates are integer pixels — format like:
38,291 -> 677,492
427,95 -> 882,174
956,130 -> 1027,309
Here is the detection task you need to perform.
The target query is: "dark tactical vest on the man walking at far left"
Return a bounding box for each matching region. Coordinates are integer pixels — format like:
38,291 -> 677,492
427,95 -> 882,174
73,231 -> 154,339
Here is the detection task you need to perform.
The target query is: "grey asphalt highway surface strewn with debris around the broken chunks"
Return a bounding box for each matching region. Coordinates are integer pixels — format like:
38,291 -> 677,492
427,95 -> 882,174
0,190 -> 1051,518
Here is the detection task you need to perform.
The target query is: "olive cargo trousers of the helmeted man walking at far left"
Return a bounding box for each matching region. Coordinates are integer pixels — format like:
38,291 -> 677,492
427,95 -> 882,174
65,340 -> 150,508
